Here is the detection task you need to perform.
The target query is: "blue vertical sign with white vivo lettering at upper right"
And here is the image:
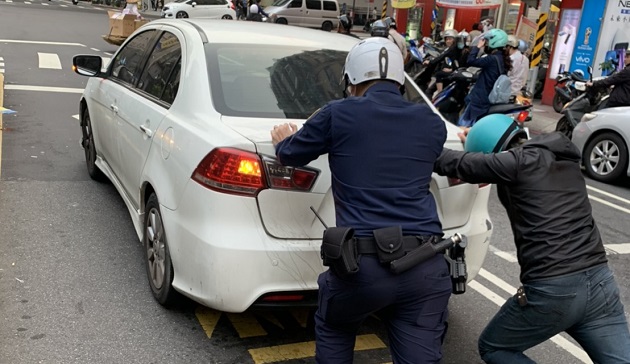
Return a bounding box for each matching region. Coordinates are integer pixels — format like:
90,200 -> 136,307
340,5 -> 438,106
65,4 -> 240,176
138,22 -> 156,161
569,0 -> 606,77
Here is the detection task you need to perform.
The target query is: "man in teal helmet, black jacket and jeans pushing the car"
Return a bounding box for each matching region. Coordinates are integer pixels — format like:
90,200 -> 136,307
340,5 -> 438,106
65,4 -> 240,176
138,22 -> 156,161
434,114 -> 630,364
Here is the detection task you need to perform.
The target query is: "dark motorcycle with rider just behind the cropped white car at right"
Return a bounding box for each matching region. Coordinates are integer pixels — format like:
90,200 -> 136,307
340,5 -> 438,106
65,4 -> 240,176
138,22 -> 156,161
556,67 -> 609,139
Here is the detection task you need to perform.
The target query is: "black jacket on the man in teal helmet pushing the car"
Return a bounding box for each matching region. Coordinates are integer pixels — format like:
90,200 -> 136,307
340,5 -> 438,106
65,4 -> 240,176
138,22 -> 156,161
434,132 -> 607,282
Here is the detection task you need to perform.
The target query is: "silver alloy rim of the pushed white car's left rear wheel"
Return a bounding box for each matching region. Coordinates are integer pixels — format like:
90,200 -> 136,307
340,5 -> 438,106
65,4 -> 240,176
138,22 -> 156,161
145,208 -> 166,289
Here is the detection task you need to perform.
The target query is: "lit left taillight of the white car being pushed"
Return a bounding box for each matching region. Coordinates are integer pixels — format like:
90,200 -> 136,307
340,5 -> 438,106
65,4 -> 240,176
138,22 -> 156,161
192,148 -> 319,197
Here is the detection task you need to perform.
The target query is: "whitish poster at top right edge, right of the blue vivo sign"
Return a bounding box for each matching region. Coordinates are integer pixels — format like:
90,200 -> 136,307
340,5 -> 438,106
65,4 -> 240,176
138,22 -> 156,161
593,0 -> 630,76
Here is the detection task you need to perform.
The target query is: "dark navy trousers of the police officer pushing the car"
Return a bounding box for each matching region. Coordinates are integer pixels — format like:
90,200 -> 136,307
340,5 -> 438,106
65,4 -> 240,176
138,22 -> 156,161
315,254 -> 452,364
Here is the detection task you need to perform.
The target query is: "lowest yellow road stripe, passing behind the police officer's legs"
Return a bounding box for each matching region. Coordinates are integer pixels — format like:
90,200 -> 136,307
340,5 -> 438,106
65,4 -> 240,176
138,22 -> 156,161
249,334 -> 386,364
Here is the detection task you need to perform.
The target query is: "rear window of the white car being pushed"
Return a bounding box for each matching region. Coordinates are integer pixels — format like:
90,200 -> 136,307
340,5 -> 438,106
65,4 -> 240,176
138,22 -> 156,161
206,44 -> 425,119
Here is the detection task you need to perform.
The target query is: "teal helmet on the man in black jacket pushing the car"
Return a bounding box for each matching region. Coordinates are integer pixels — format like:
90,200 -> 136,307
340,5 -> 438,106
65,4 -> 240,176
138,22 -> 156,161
464,114 -> 527,153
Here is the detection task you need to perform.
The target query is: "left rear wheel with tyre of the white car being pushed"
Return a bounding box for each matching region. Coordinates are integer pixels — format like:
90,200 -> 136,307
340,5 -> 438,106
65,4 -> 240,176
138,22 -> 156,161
143,193 -> 180,306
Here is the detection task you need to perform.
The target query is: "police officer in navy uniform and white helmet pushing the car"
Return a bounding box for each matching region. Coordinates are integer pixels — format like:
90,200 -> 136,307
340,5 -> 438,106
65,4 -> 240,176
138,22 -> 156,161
271,37 -> 452,364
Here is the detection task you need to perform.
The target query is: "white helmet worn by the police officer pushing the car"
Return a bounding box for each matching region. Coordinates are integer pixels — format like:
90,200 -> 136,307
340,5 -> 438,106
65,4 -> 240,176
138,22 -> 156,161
343,37 -> 405,85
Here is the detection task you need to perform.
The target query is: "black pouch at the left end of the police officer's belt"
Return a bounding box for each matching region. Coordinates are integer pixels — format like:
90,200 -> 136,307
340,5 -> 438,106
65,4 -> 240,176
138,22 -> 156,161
321,227 -> 359,276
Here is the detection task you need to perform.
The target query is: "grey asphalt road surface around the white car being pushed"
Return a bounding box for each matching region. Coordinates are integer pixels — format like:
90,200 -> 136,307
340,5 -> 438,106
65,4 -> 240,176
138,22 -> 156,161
0,0 -> 630,364
